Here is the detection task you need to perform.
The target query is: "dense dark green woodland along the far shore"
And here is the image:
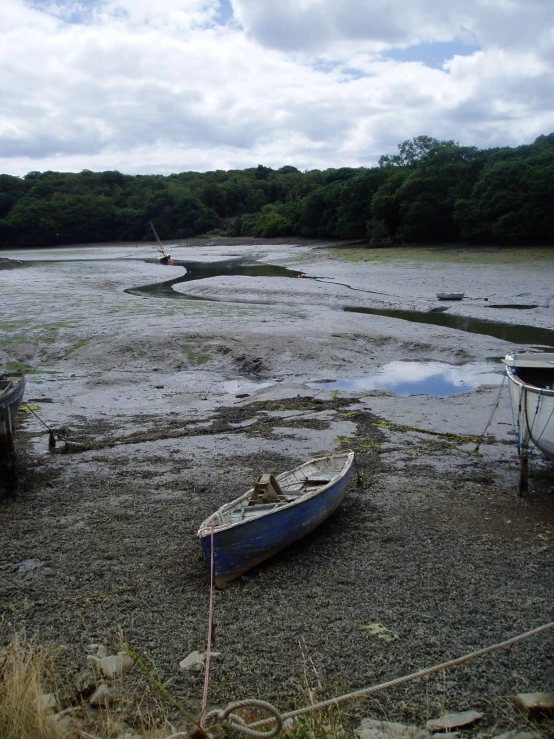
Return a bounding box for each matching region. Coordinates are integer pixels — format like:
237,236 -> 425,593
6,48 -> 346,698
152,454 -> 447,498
0,133 -> 554,248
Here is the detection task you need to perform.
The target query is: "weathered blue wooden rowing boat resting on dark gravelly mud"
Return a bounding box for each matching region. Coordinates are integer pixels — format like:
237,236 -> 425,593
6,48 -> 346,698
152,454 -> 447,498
198,451 -> 354,587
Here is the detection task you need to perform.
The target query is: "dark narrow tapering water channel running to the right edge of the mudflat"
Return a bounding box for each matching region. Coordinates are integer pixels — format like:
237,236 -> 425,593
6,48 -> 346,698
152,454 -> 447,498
343,306 -> 554,347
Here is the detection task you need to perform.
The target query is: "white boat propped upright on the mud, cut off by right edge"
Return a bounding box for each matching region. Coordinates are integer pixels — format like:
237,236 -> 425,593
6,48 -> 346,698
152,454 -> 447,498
502,353 -> 554,492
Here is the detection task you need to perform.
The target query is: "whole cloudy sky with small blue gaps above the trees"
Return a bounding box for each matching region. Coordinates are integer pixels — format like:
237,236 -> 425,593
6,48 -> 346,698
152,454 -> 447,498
0,0 -> 554,175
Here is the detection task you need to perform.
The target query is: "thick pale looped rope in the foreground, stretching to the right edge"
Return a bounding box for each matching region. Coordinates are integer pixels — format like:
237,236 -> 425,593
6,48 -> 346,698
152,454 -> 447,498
199,621 -> 554,737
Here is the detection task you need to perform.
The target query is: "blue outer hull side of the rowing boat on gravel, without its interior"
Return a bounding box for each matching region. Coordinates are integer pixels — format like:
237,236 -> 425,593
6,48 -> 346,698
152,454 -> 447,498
199,454 -> 352,587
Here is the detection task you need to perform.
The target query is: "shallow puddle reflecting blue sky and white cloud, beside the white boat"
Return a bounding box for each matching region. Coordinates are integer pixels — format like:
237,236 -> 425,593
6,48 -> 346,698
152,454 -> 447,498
308,361 -> 502,398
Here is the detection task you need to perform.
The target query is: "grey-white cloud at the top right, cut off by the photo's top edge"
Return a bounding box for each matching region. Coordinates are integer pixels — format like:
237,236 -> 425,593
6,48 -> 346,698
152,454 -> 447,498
233,0 -> 553,51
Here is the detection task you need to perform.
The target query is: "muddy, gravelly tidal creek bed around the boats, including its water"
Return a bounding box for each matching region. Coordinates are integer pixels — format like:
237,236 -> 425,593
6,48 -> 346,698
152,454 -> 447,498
0,239 -> 554,731
